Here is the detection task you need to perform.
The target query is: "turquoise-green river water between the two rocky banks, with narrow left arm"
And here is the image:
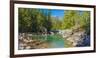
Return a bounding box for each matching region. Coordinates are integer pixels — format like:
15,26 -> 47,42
33,34 -> 64,48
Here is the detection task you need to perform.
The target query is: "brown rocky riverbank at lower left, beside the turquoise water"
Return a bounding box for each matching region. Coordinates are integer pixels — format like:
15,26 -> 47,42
19,33 -> 49,50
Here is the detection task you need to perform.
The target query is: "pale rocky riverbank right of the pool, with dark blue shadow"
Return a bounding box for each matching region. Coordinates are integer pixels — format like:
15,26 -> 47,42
64,25 -> 90,47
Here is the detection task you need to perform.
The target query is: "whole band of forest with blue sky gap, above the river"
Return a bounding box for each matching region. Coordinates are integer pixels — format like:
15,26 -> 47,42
18,8 -> 90,34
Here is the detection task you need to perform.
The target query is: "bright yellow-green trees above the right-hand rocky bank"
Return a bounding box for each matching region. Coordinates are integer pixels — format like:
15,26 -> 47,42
62,10 -> 90,34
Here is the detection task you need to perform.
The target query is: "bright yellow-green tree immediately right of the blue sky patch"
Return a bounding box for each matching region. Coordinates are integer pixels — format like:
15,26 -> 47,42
62,10 -> 79,29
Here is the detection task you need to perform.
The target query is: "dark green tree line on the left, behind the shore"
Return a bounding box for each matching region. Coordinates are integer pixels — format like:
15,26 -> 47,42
18,8 -> 52,32
